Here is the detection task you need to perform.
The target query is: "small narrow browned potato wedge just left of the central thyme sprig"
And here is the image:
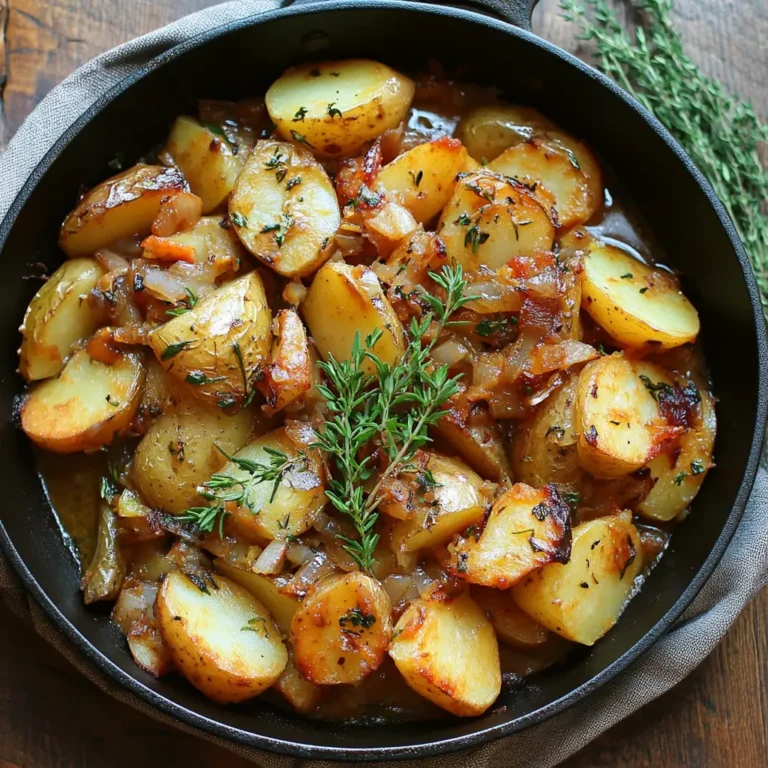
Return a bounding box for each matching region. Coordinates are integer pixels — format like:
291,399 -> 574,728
256,309 -> 312,413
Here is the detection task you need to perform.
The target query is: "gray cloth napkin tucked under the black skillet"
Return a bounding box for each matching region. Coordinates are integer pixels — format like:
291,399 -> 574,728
0,0 -> 768,768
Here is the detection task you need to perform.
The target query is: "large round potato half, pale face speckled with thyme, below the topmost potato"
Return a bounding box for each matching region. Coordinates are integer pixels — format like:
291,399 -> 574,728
229,141 -> 341,277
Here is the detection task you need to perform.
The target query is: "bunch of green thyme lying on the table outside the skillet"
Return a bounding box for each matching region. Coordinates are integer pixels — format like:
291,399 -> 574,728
560,0 -> 768,312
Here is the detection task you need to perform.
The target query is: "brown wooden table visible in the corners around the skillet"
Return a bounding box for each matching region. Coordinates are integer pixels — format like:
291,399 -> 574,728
0,0 -> 768,768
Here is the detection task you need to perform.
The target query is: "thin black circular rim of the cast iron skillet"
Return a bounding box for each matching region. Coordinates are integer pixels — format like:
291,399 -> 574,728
0,0 -> 768,762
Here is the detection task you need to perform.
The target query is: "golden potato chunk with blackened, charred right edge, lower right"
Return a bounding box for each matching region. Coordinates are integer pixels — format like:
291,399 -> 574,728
452,483 -> 571,589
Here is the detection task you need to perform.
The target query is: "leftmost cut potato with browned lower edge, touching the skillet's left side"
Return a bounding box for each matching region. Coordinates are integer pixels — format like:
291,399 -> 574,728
21,350 -> 144,453
